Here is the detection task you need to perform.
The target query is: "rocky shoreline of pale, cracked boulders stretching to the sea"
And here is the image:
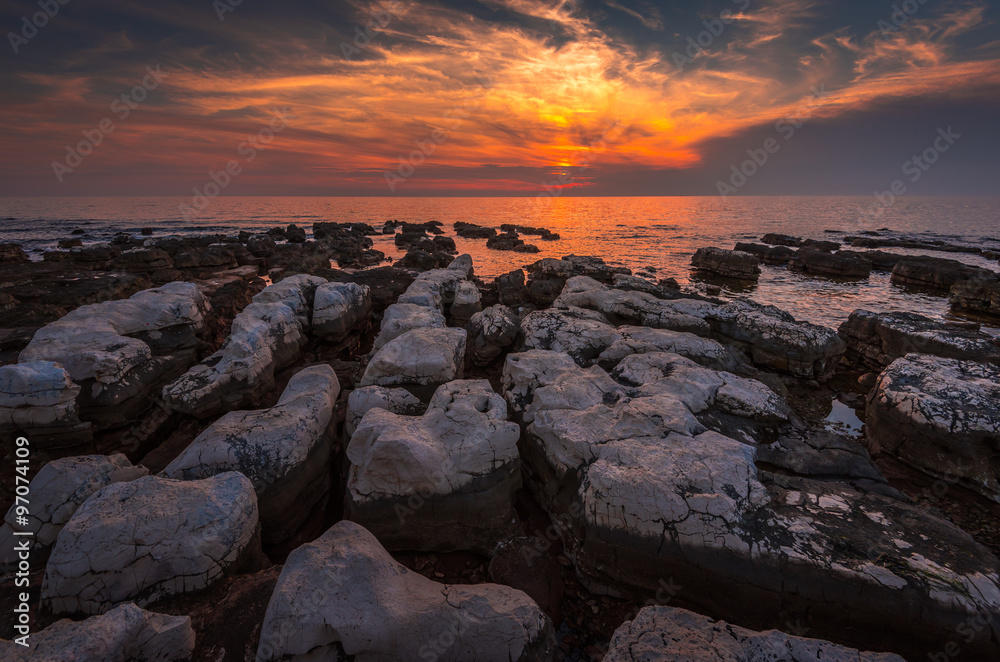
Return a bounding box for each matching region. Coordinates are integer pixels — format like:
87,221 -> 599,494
0,221 -> 1000,662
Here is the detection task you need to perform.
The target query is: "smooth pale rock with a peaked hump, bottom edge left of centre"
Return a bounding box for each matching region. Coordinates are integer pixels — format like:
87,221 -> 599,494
257,521 -> 555,662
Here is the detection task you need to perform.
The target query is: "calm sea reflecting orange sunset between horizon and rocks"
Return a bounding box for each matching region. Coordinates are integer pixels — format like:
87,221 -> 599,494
0,197 -> 1000,334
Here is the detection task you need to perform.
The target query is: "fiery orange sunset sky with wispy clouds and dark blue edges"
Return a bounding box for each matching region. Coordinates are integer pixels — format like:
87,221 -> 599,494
0,0 -> 1000,196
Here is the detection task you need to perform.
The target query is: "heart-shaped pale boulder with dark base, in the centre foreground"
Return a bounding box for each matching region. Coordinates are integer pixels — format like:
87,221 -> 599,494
346,380 -> 521,555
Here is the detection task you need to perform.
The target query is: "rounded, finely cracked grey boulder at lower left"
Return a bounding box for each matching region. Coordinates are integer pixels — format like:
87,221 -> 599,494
42,472 -> 259,614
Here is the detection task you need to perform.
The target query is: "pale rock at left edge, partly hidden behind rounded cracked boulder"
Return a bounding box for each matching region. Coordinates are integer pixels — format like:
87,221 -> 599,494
0,453 -> 149,567
